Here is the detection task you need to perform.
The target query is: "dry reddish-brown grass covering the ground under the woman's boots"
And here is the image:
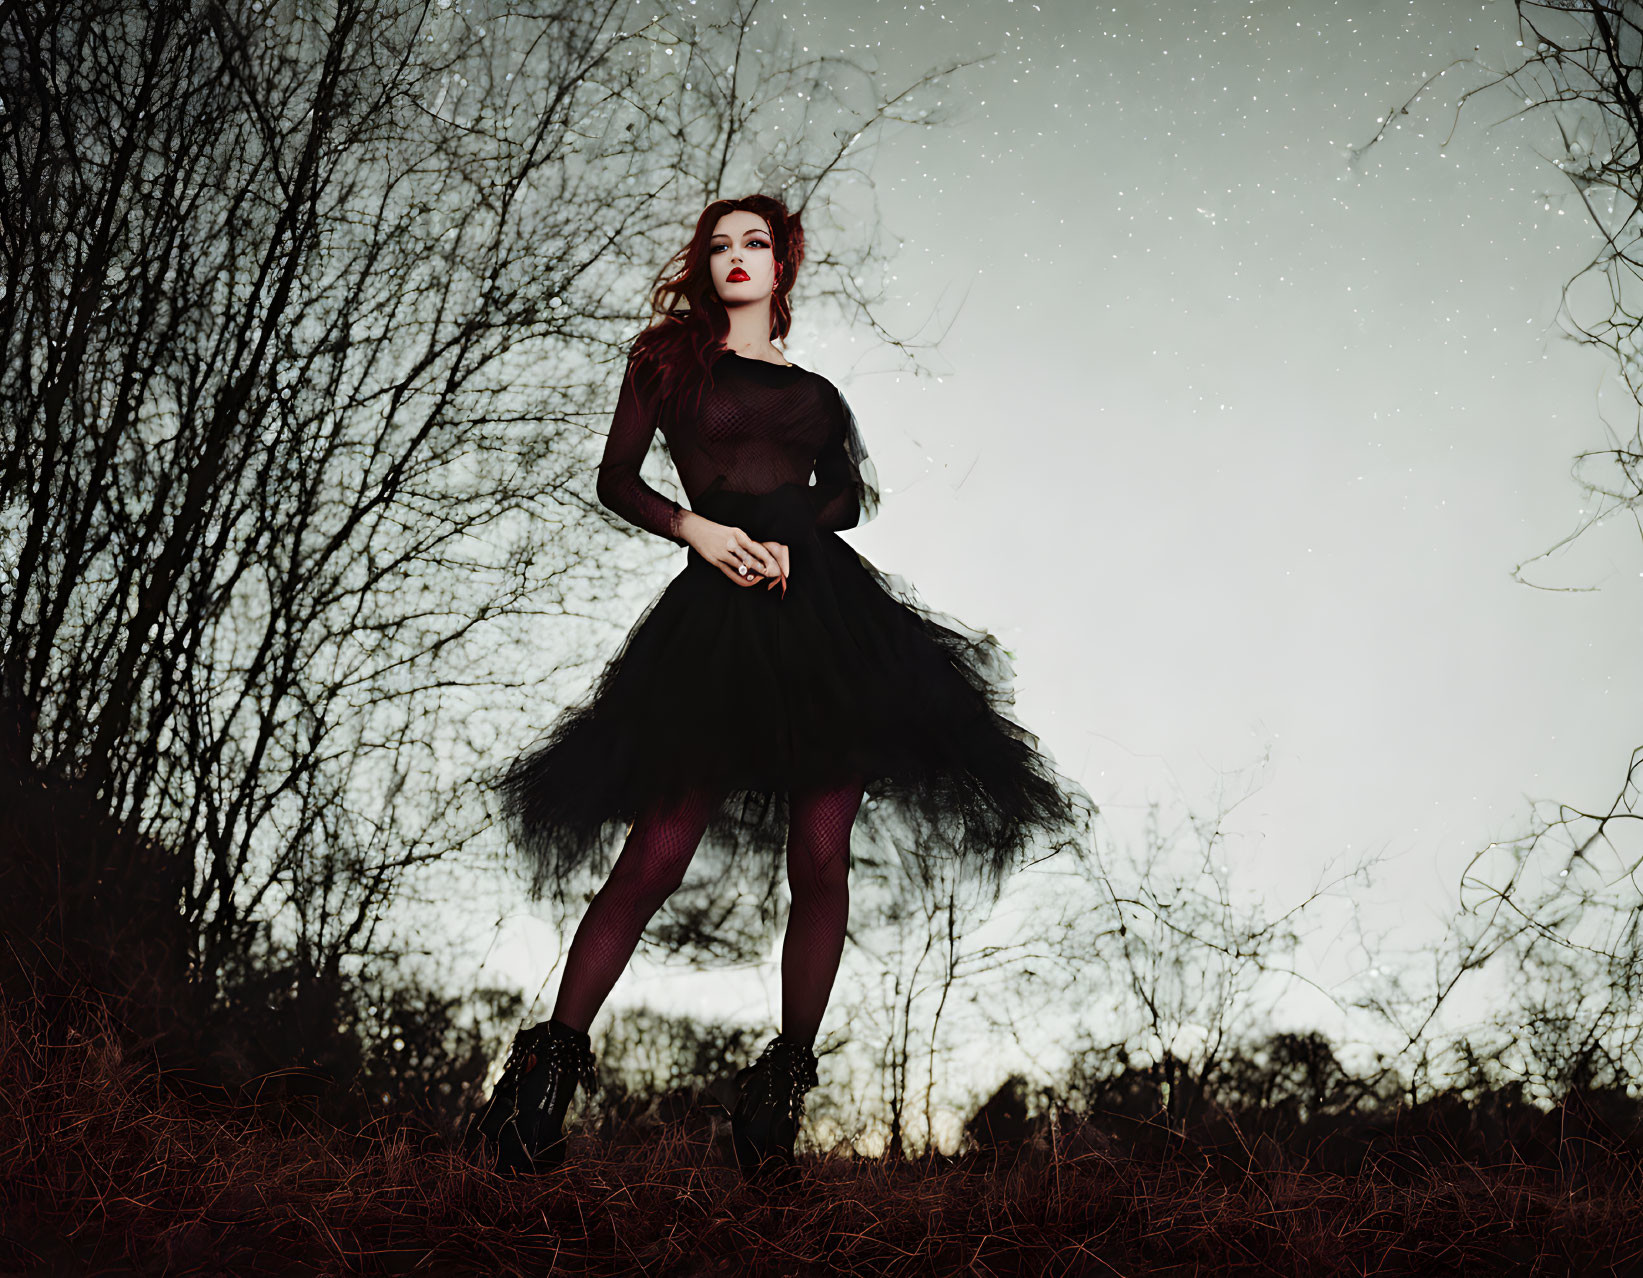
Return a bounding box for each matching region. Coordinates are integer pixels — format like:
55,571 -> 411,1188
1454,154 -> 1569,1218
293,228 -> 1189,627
0,1000 -> 1643,1275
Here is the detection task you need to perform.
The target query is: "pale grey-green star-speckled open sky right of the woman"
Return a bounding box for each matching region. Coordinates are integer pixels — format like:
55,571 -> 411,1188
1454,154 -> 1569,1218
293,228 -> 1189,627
453,0 -> 1643,1136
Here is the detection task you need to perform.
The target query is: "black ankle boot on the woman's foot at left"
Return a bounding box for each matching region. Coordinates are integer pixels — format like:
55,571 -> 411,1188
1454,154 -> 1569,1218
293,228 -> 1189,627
468,1020 -> 595,1175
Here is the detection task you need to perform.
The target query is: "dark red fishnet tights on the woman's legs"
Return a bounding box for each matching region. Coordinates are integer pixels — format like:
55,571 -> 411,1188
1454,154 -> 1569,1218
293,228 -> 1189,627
554,780 -> 863,1043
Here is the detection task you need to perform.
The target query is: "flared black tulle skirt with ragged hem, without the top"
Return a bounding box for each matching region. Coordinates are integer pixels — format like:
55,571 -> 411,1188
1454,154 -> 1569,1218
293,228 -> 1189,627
495,485 -> 1096,895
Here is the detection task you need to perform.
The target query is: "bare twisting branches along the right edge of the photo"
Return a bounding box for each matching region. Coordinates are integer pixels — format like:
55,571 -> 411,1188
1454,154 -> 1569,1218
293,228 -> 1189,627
1354,0 -> 1643,1099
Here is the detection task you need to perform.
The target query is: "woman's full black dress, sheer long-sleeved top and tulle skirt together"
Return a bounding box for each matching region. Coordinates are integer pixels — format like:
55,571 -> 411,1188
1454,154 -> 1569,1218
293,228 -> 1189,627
496,350 -> 1096,913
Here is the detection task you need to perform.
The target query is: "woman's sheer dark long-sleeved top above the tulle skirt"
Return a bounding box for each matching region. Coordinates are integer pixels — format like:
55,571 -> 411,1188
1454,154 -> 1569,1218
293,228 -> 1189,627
598,350 -> 879,545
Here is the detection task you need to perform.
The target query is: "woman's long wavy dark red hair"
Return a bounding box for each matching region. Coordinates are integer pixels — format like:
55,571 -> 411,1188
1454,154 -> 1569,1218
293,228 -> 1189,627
633,195 -> 805,423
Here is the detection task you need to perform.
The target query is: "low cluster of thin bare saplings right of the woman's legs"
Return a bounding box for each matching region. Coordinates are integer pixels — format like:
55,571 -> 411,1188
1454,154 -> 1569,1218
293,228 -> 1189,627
818,755 -> 1390,1156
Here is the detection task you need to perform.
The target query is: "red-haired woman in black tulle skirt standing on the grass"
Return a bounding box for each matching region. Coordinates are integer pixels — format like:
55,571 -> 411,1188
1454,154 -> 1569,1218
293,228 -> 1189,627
475,195 -> 1094,1175
